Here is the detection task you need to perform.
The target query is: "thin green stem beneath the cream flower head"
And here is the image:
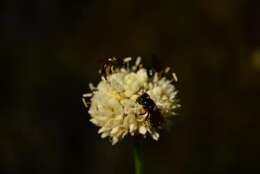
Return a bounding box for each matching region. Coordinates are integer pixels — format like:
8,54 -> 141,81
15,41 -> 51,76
133,138 -> 143,174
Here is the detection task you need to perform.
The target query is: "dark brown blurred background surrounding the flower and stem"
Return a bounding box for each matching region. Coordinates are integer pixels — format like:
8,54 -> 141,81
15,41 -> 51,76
0,0 -> 260,174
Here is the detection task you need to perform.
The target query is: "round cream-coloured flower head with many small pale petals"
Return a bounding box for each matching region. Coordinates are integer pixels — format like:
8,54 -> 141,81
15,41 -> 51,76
83,57 -> 180,145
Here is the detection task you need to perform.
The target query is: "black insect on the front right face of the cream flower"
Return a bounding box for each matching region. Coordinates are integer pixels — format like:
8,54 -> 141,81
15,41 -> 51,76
136,93 -> 164,129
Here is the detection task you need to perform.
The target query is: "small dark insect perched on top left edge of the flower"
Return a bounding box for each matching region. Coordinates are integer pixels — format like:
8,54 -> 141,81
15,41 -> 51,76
101,57 -> 126,78
